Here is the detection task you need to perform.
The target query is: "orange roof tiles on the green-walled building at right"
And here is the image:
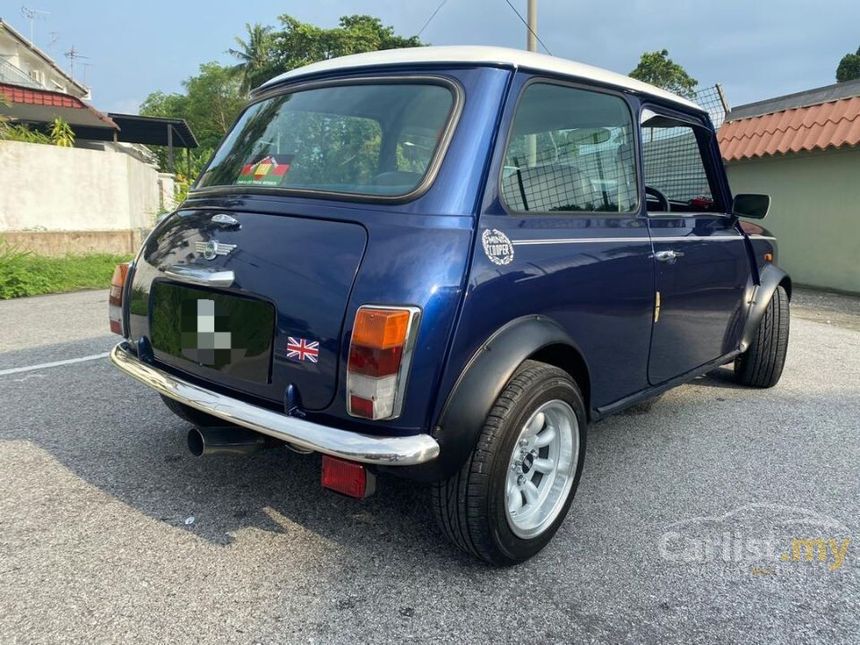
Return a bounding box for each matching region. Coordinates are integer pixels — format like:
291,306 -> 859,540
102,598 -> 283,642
718,96 -> 860,161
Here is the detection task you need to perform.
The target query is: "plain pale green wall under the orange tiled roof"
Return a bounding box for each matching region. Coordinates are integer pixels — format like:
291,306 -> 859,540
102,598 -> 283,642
726,148 -> 860,293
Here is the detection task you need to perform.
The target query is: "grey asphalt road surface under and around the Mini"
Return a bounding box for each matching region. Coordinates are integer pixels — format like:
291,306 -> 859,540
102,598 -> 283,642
0,292 -> 860,643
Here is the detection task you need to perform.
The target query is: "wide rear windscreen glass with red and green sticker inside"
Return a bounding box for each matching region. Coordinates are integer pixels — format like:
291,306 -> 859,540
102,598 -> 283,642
196,82 -> 455,196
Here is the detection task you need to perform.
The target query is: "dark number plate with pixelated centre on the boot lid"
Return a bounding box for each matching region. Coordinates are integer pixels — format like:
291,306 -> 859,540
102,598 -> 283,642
150,282 -> 275,383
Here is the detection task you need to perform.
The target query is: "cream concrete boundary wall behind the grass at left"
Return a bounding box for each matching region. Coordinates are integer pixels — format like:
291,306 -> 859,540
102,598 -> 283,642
0,141 -> 173,254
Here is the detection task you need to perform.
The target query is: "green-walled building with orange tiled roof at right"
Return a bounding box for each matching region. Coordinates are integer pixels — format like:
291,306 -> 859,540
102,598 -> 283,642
719,80 -> 860,293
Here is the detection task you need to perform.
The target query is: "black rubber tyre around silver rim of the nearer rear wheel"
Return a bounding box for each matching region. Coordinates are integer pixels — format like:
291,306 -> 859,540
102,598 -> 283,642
431,361 -> 586,566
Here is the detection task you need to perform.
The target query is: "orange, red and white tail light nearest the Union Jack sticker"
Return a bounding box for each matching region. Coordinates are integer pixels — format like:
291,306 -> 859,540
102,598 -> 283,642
346,306 -> 420,420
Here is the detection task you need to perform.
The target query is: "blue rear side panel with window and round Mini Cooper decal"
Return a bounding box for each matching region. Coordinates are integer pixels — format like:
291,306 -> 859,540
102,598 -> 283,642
451,74 -> 654,408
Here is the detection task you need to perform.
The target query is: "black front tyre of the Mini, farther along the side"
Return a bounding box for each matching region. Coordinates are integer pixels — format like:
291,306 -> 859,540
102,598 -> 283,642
735,287 -> 789,387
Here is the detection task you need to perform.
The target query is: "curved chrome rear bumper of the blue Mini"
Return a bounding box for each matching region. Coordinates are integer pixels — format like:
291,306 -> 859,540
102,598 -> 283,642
110,342 -> 439,466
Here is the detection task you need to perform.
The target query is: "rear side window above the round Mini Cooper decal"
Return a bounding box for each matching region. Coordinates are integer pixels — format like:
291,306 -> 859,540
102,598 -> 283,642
501,83 -> 638,213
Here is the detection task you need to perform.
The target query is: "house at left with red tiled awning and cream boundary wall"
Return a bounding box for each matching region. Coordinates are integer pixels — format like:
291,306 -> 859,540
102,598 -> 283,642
0,17 -> 197,255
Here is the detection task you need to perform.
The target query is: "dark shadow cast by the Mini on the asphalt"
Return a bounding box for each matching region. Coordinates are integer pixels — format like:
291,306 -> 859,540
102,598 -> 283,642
0,366 -> 764,566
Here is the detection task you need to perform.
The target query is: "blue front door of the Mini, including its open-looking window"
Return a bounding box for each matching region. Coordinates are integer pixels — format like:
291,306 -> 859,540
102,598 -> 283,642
640,107 -> 750,384
